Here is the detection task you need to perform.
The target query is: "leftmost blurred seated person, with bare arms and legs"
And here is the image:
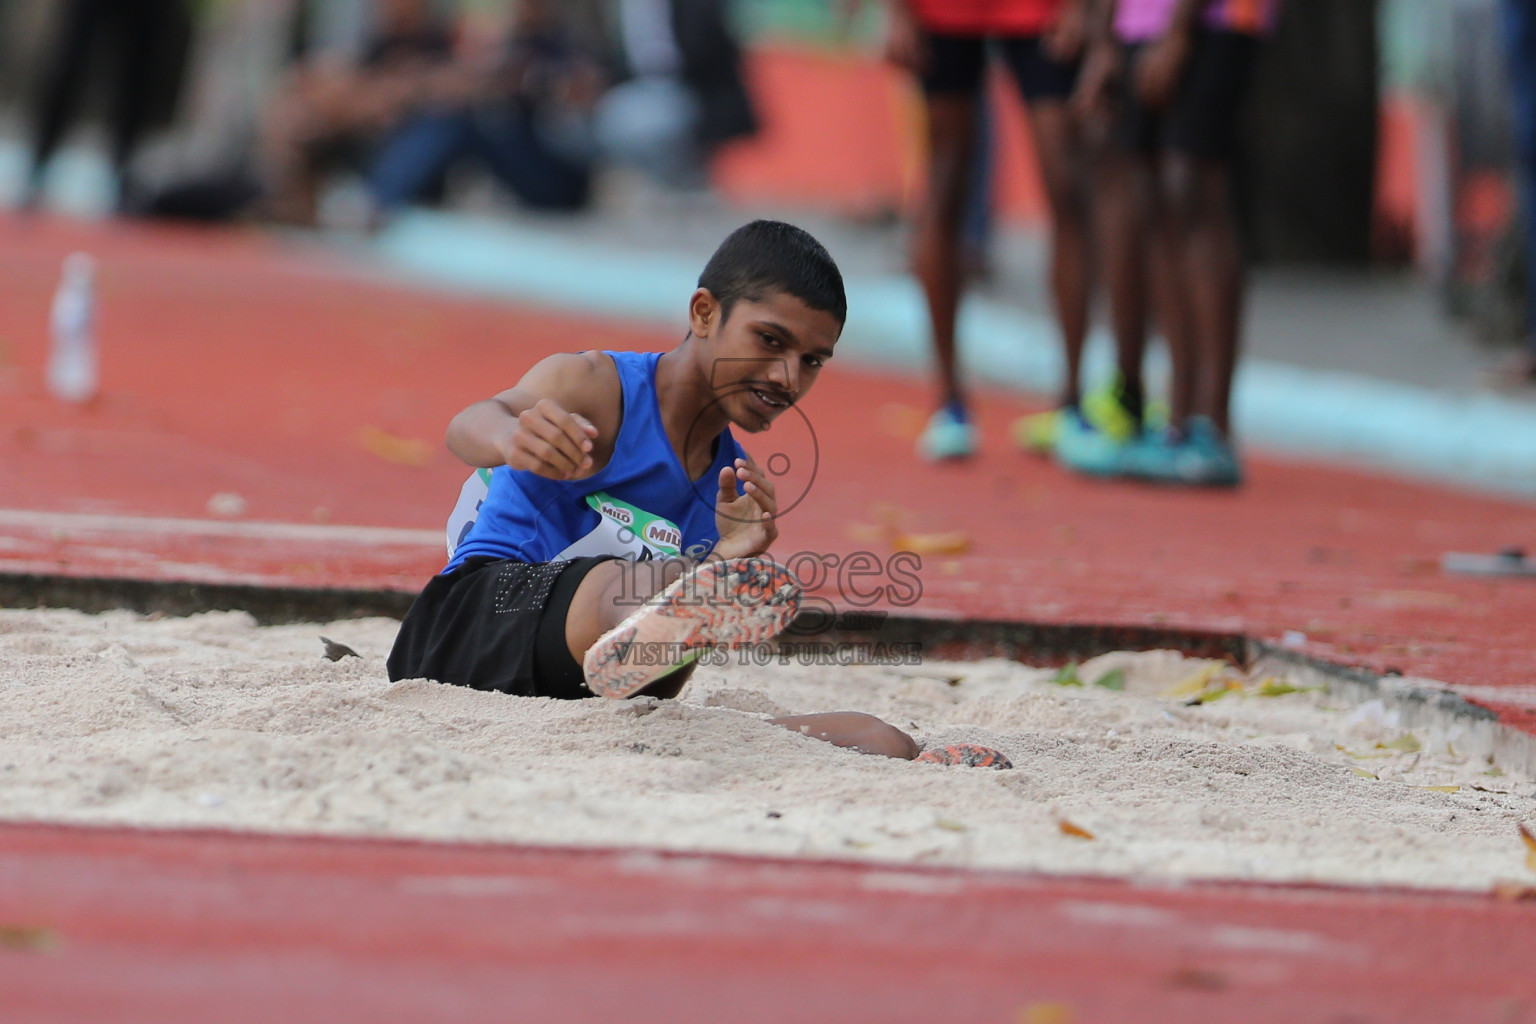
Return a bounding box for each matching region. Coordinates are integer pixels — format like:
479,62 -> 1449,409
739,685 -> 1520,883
261,0 -> 453,226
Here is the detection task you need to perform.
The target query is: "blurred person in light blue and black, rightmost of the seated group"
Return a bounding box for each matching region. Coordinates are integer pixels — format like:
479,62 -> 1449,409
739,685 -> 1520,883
594,0 -> 757,187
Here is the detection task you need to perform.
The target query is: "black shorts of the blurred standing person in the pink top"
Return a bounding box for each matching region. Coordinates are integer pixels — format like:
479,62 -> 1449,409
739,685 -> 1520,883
1115,29 -> 1260,160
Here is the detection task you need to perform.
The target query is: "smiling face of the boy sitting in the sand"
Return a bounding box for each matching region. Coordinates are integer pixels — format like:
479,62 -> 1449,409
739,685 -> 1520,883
690,289 -> 843,433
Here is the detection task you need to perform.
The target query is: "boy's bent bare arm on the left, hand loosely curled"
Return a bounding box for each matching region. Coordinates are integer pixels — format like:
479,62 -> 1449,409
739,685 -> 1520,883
447,353 -> 622,481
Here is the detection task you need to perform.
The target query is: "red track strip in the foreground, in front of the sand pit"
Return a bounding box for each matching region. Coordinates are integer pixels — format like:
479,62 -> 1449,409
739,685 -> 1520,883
0,826 -> 1536,1024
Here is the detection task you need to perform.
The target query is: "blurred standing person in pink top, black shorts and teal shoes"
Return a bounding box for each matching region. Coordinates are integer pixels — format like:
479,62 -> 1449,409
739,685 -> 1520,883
1057,0 -> 1278,487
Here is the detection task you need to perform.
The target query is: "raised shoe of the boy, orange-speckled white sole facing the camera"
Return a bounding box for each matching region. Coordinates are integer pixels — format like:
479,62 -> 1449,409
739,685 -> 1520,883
582,559 -> 800,699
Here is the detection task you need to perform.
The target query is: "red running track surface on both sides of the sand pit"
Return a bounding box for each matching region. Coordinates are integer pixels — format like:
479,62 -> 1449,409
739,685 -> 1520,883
0,221 -> 1536,1024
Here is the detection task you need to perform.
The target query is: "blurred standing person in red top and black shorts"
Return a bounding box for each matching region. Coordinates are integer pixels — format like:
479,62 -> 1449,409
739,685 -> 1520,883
886,0 -> 1092,461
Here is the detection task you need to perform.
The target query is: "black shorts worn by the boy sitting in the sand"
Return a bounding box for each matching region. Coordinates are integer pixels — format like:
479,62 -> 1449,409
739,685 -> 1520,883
389,557 -> 608,700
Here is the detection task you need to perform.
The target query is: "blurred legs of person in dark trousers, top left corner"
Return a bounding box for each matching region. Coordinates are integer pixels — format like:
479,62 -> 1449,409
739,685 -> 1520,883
22,0 -> 192,209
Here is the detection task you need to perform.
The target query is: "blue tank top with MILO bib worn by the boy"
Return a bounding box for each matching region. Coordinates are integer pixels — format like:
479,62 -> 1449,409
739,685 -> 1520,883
444,352 -> 746,571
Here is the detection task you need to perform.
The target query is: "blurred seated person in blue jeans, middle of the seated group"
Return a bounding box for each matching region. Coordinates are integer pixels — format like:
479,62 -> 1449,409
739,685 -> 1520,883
369,0 -> 607,213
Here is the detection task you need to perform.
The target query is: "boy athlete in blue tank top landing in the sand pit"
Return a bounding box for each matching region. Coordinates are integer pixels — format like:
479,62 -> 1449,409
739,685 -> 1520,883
389,221 -> 983,766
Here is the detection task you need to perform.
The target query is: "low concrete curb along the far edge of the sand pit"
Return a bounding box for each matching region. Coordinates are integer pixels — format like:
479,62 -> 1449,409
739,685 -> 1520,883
12,573 -> 1536,777
